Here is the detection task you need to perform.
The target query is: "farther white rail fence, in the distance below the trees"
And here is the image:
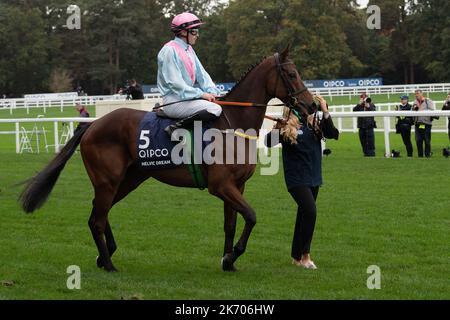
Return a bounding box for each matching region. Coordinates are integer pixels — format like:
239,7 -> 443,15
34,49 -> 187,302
0,83 -> 450,114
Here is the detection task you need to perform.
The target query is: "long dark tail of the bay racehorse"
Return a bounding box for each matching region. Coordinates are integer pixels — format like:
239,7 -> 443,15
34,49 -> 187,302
19,124 -> 90,213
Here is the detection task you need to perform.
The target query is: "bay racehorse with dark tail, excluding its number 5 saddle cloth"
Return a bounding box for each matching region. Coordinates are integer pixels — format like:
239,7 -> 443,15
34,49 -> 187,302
19,46 -> 317,272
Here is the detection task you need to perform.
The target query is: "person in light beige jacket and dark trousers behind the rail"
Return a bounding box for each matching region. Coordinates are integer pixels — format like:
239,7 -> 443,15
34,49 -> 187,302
413,90 -> 435,158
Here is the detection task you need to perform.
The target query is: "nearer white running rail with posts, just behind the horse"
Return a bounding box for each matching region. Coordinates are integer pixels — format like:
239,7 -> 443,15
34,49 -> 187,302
0,110 -> 450,157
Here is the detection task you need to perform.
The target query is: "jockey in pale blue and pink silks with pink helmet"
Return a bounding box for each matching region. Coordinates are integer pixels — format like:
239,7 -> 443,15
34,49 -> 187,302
157,12 -> 222,136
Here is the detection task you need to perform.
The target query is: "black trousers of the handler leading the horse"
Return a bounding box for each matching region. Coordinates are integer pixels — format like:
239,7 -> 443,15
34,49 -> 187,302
289,187 -> 319,260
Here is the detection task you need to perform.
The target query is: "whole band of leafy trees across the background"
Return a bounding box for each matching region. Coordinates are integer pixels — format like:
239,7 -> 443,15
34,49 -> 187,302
0,0 -> 450,96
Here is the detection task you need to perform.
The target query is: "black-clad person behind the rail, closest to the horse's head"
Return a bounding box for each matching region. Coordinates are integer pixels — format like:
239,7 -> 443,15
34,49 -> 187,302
353,94 -> 377,157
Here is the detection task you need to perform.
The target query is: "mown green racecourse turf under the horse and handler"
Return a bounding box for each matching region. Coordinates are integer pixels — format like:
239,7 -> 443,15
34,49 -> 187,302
0,133 -> 450,299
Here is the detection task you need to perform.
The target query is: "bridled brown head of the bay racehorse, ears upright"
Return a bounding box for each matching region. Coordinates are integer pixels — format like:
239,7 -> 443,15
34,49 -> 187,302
267,45 -> 317,118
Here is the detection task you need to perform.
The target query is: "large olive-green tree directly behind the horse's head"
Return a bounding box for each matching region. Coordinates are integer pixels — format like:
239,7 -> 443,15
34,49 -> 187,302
225,0 -> 362,79
